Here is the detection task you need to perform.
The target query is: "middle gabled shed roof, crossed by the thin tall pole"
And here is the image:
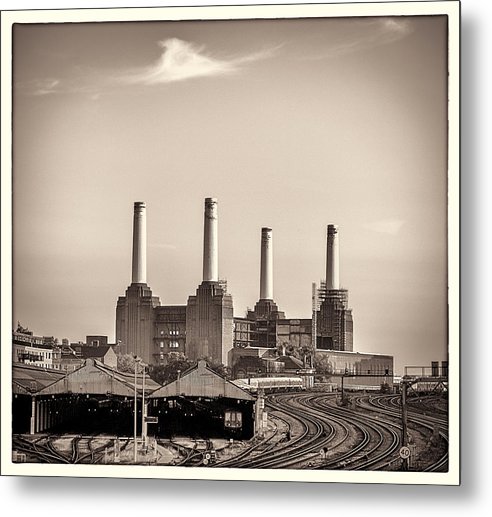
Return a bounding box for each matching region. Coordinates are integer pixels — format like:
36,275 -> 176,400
37,359 -> 160,397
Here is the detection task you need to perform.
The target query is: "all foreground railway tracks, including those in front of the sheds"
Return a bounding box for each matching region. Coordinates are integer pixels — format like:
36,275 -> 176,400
13,392 -> 449,472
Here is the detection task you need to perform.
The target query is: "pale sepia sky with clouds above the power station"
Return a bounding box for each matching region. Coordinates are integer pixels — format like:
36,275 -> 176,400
13,16 -> 447,372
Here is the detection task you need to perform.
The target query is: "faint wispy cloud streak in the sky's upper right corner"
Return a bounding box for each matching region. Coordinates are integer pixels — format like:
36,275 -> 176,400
307,17 -> 413,59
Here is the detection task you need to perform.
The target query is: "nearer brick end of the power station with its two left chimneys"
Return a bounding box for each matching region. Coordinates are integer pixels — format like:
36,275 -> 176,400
116,198 -> 234,364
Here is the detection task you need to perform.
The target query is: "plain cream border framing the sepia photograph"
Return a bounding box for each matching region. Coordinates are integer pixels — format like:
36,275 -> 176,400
1,0 -> 460,485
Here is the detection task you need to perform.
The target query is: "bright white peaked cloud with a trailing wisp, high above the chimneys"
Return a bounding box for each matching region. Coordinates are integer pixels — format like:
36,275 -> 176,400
121,38 -> 279,85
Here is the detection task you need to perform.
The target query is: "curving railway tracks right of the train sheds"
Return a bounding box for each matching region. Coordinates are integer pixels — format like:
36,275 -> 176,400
213,393 -> 447,471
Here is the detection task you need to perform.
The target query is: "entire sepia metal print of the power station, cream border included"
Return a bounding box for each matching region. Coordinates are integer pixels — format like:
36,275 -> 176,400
1,1 -> 460,485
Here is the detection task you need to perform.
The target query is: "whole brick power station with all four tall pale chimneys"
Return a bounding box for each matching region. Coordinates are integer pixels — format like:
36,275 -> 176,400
116,198 -> 368,367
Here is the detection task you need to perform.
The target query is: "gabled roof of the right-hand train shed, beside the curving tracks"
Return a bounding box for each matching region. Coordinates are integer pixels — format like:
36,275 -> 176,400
150,361 -> 256,400
